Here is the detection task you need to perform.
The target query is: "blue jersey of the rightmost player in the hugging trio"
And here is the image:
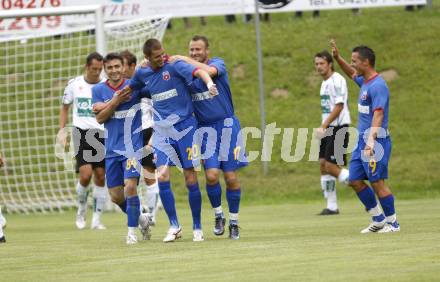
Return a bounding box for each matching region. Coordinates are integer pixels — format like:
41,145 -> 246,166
191,58 -> 234,124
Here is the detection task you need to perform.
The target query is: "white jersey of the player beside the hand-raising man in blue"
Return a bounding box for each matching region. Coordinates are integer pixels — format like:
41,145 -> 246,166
320,72 -> 351,126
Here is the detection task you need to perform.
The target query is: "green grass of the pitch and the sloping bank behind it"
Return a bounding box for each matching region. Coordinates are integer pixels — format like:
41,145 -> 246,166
0,4 -> 440,281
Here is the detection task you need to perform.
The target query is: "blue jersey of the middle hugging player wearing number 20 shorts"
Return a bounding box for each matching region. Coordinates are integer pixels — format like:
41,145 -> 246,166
130,61 -> 197,126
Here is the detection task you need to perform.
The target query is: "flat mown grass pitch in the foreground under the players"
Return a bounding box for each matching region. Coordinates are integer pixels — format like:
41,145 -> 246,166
0,197 -> 440,281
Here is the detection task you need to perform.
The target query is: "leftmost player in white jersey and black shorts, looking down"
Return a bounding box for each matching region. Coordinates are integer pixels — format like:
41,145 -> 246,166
58,52 -> 108,229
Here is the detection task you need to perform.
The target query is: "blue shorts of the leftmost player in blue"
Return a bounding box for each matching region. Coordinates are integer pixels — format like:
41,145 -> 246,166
105,156 -> 141,189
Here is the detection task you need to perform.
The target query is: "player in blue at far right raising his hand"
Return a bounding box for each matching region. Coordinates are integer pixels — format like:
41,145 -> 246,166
331,40 -> 400,233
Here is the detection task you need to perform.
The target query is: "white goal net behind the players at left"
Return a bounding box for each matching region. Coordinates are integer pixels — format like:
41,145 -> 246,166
0,8 -> 169,213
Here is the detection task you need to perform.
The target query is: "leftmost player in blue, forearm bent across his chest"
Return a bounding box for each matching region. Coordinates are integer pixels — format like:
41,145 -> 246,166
92,53 -> 150,245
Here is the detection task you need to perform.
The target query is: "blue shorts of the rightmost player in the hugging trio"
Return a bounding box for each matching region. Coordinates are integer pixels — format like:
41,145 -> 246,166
197,116 -> 248,172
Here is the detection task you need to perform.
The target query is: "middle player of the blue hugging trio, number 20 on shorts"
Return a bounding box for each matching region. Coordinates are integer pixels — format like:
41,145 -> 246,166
121,39 -> 217,242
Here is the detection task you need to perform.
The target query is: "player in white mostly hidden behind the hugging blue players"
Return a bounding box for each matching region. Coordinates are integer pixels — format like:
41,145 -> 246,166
120,50 -> 160,225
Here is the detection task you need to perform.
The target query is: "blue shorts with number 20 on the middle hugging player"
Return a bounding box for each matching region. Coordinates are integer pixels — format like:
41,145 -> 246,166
153,116 -> 200,169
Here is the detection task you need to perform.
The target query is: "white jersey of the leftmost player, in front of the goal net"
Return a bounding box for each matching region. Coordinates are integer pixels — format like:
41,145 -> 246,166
62,75 -> 104,130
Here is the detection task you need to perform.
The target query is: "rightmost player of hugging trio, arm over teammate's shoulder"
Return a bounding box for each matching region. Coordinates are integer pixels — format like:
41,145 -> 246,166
173,35 -> 247,239
